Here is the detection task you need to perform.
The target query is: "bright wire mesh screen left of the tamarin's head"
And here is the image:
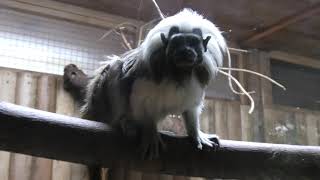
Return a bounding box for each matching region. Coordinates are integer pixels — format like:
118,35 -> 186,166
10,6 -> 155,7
0,8 -> 124,74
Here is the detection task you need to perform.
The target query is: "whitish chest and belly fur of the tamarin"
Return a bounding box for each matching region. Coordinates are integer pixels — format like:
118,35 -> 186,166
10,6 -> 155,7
130,78 -> 204,121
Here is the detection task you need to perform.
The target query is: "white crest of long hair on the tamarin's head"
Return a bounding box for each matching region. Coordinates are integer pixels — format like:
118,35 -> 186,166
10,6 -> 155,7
141,8 -> 227,73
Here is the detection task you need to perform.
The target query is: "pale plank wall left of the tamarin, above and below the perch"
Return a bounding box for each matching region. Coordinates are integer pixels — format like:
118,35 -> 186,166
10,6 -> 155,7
0,68 -> 89,180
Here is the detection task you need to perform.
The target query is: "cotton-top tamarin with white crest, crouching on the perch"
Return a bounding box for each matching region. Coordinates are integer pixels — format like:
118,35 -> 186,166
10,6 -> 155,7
63,9 -> 227,180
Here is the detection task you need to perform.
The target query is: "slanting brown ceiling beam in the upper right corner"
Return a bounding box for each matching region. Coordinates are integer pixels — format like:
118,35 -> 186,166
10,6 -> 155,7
240,3 -> 320,45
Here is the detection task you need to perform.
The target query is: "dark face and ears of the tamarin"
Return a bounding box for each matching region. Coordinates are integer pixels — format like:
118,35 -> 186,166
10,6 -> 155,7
161,26 -> 210,69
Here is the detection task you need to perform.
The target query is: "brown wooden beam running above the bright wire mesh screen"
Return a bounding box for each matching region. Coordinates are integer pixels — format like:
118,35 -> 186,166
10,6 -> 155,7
0,0 -> 143,28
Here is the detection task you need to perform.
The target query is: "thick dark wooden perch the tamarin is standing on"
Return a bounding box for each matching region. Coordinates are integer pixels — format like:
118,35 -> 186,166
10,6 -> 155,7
0,102 -> 320,179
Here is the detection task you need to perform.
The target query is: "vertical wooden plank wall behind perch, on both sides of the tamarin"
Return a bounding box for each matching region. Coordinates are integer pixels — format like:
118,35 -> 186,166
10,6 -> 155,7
0,51 -> 320,180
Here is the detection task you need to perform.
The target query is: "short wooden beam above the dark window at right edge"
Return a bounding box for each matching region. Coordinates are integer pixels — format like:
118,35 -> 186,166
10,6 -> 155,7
270,51 -> 320,69
